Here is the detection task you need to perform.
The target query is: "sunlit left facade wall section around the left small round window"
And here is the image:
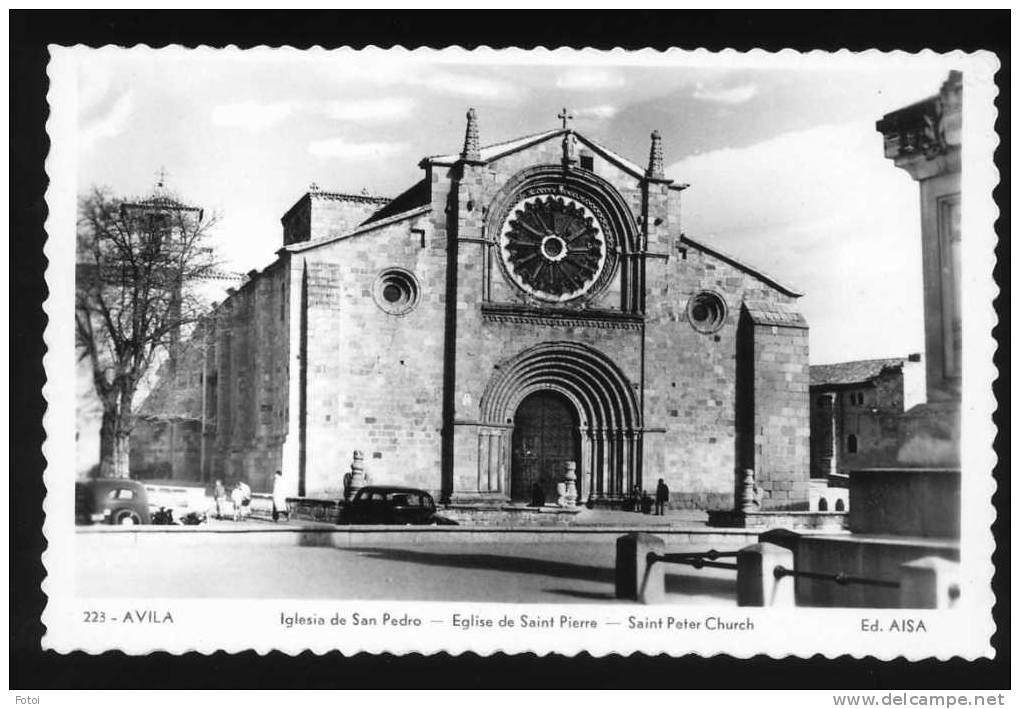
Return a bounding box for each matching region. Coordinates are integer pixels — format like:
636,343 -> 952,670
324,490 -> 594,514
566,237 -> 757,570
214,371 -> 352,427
291,214 -> 446,498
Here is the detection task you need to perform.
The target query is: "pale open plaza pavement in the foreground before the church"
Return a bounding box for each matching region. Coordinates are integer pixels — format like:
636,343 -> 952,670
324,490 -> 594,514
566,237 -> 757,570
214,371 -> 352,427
75,515 -> 748,605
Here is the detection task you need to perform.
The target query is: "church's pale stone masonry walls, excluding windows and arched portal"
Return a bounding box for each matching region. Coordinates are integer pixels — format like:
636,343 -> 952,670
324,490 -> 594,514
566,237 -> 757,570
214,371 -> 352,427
153,129 -> 808,508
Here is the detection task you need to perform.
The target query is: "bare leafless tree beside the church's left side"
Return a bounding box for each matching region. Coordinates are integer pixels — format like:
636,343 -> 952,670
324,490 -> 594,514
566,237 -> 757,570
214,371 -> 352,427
74,188 -> 216,477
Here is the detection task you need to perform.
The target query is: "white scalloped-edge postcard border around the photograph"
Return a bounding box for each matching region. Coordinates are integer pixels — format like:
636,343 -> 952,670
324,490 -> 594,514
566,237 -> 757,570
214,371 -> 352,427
42,45 -> 995,660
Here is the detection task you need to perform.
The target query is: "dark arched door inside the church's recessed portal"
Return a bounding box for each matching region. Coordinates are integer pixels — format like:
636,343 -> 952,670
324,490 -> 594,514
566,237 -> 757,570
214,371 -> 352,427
510,391 -> 580,502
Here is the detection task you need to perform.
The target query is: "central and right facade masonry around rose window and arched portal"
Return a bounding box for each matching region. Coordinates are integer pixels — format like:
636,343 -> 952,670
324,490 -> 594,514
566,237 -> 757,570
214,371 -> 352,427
442,134 -> 808,508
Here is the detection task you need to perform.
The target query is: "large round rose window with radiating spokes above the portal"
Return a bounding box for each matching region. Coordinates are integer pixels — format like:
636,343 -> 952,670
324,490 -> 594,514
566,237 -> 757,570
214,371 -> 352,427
500,195 -> 607,302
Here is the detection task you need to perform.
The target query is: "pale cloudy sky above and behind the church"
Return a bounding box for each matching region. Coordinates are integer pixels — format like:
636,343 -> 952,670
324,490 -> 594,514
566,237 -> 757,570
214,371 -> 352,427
77,48 -> 952,363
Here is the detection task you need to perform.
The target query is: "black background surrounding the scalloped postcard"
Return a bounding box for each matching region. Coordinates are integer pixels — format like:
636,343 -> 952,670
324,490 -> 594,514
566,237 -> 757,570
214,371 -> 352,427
9,10 -> 1010,690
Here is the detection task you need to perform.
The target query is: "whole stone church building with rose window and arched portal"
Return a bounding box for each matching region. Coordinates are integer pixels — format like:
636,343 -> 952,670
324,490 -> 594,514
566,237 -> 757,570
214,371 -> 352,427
141,110 -> 809,509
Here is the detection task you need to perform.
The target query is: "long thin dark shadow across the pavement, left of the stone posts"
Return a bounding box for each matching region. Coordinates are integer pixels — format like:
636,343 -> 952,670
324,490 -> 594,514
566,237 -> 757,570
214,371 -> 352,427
344,547 -> 614,584
